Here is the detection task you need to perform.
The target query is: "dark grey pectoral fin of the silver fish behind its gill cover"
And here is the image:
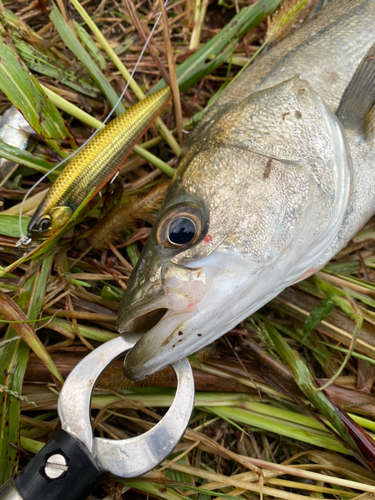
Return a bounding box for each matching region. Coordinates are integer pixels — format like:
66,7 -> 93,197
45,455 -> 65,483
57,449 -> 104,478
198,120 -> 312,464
336,43 -> 375,135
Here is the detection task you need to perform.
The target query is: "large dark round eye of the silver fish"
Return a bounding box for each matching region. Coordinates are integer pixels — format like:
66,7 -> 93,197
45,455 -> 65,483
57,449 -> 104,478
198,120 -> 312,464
156,205 -> 207,248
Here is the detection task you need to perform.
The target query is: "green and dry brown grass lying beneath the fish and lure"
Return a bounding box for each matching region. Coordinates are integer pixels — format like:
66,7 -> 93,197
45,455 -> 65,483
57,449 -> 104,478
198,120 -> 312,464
0,0 -> 375,500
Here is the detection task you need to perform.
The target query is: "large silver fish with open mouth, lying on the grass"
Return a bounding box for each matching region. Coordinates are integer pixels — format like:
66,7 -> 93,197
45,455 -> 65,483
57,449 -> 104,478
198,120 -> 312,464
118,0 -> 375,380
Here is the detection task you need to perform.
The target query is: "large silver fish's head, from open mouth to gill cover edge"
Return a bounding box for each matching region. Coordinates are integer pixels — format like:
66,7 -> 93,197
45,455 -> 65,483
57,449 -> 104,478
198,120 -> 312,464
118,76 -> 351,380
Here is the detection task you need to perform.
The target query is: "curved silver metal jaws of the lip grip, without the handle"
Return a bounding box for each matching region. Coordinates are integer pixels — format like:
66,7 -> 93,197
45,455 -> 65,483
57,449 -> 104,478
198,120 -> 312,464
58,335 -> 194,478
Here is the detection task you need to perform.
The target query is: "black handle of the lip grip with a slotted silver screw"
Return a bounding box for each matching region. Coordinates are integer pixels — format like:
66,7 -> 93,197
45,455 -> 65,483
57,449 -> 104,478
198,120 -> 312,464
14,430 -> 104,500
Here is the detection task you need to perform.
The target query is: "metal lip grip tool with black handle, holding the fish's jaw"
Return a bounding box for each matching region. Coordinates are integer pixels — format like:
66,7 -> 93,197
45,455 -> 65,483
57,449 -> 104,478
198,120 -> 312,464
0,335 -> 194,500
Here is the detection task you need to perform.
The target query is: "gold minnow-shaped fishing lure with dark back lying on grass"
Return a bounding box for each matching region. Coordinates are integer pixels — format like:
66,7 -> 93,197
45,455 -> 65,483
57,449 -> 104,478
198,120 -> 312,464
28,87 -> 171,238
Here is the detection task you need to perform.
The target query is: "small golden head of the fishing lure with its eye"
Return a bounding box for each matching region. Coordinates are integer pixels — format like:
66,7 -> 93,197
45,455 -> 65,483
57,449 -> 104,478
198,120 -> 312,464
27,205 -> 73,239
